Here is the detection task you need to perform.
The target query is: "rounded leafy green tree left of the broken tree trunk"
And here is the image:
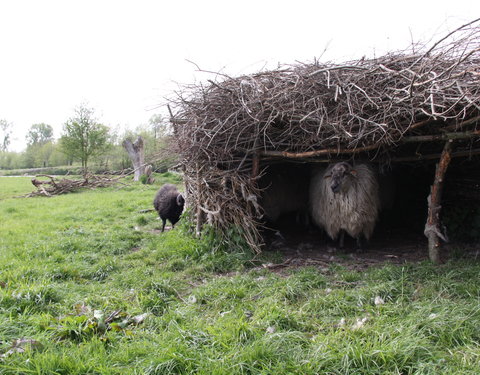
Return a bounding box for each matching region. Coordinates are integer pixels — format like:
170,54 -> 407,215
60,104 -> 110,172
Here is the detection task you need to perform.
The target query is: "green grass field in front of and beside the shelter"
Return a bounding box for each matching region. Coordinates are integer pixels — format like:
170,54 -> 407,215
0,175 -> 480,375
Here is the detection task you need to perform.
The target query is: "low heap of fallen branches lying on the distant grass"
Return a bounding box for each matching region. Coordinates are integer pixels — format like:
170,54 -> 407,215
23,174 -> 125,198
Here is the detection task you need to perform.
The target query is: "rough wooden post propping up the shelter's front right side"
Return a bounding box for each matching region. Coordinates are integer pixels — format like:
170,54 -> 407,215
424,139 -> 453,264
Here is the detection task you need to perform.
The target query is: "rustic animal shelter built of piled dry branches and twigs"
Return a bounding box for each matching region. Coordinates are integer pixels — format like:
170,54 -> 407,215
170,20 -> 480,262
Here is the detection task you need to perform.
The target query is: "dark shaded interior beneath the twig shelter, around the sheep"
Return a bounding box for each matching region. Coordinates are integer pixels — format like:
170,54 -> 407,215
259,157 -> 480,258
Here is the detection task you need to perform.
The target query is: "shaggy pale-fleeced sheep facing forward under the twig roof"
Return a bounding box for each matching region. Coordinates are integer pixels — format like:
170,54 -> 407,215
310,162 -> 380,248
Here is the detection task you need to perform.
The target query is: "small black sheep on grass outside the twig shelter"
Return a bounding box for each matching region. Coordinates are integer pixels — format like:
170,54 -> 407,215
153,184 -> 185,232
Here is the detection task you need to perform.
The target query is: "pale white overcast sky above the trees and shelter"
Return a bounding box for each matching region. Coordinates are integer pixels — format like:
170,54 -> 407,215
0,0 -> 480,151
